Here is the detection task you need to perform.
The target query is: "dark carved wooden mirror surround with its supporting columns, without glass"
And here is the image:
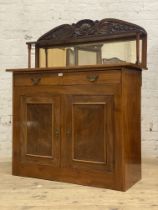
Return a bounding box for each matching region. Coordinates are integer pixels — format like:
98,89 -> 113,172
27,18 -> 147,69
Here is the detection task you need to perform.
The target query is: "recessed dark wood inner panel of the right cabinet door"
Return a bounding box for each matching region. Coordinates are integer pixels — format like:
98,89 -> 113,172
72,102 -> 106,163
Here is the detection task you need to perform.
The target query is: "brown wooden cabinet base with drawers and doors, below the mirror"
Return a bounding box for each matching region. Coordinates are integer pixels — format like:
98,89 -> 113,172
10,67 -> 141,191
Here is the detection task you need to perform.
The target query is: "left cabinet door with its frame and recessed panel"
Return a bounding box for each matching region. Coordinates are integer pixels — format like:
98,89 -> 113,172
20,96 -> 60,166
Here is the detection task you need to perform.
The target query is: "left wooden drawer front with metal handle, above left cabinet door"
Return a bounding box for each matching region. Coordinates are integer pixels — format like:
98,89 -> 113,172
14,74 -> 62,86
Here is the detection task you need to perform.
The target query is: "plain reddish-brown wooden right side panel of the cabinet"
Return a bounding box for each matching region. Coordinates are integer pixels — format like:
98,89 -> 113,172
122,69 -> 141,190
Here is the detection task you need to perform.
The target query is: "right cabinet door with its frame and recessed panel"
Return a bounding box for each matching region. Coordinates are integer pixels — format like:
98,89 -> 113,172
62,95 -> 114,171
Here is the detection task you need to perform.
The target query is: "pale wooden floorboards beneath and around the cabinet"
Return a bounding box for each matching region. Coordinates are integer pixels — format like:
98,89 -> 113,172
0,160 -> 158,210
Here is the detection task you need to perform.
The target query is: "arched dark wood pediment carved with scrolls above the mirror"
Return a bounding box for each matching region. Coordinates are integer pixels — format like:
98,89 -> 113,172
37,19 -> 146,46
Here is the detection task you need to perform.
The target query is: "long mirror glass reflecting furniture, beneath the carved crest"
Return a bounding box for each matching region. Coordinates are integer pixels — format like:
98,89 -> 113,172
39,40 -> 142,67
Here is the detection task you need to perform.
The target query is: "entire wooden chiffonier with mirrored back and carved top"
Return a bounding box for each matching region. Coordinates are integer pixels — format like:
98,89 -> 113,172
7,19 -> 147,191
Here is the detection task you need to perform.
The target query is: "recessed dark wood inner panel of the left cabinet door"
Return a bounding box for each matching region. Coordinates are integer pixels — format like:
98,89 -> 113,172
27,104 -> 54,156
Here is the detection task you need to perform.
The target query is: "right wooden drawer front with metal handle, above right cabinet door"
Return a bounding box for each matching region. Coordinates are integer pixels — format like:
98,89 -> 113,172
63,70 -> 121,85
